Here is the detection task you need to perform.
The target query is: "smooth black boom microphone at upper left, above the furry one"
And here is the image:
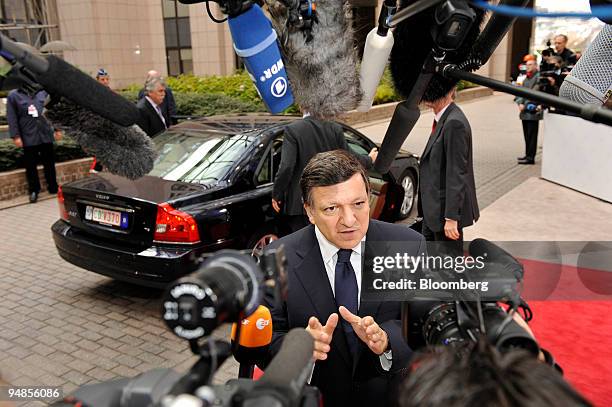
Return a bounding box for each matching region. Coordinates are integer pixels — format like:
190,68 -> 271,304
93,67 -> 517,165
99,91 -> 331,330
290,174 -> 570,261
0,34 -> 140,126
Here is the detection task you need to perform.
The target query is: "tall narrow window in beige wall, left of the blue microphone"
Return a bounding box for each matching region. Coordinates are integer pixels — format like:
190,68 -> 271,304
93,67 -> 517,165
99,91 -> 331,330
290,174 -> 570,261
161,0 -> 193,76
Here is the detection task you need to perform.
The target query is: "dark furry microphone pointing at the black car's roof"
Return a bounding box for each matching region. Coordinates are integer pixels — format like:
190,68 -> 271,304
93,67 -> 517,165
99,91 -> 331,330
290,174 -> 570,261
45,99 -> 157,179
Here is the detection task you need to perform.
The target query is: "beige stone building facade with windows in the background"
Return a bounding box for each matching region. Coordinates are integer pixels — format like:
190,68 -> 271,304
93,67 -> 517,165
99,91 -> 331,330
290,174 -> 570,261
0,0 -> 512,88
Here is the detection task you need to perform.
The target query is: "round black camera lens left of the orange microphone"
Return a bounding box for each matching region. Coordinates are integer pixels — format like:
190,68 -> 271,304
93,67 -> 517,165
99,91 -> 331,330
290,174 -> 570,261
162,250 -> 262,340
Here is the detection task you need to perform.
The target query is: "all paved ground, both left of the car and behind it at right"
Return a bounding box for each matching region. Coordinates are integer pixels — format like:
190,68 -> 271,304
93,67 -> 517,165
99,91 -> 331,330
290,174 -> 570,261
0,91 -> 539,405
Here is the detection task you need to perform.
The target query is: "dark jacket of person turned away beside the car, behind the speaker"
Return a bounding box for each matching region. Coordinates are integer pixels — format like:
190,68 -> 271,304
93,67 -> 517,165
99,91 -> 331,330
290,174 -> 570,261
272,117 -> 372,215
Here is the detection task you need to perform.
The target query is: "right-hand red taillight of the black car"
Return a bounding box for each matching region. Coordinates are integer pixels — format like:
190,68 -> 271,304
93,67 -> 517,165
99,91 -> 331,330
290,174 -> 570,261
153,203 -> 200,243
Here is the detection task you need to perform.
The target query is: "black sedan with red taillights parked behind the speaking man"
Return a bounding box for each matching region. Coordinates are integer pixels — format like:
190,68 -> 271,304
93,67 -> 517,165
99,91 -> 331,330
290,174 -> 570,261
52,115 -> 418,287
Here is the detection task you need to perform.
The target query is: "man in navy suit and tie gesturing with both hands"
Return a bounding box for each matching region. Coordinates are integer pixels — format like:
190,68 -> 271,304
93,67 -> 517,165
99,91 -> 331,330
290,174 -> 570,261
266,150 -> 425,406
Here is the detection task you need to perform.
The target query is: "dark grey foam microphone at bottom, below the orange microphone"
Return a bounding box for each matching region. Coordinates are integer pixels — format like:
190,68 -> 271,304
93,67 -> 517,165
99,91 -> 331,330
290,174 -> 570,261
245,328 -> 314,406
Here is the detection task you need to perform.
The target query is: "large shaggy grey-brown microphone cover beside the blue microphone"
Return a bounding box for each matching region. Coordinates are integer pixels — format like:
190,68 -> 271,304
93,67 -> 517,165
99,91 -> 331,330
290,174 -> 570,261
266,0 -> 361,119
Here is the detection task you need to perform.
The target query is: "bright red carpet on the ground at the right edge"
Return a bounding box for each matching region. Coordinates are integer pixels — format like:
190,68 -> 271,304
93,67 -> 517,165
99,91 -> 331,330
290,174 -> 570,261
521,260 -> 612,407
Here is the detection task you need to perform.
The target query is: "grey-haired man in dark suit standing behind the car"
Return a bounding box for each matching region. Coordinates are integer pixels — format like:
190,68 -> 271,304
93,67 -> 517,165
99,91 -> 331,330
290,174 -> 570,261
136,78 -> 168,137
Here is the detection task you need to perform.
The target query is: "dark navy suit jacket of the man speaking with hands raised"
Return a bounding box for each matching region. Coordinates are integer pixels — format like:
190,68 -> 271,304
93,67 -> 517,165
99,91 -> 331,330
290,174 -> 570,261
266,220 -> 425,406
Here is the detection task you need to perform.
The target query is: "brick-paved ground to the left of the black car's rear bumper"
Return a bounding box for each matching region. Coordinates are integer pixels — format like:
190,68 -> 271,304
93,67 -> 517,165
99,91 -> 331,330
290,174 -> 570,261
0,200 -> 237,404
